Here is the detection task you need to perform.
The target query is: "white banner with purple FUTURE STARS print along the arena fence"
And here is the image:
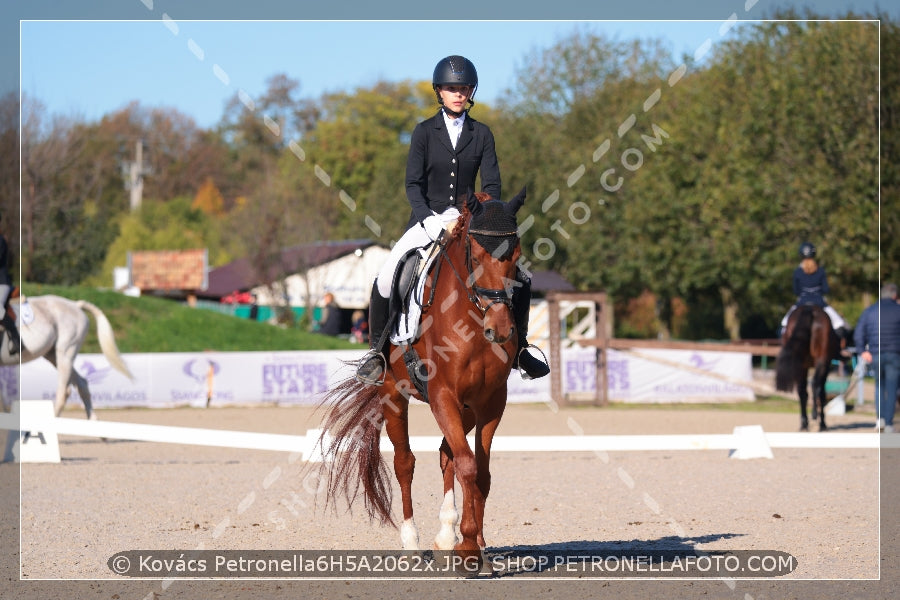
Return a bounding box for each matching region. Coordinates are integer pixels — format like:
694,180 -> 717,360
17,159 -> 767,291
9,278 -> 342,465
0,349 -> 754,408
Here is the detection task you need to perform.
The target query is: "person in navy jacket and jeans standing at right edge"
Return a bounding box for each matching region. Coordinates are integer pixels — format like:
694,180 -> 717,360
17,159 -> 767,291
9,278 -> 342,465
854,283 -> 900,433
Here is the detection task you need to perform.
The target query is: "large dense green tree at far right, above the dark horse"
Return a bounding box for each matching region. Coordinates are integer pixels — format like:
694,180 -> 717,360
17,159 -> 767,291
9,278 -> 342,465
666,22 -> 878,338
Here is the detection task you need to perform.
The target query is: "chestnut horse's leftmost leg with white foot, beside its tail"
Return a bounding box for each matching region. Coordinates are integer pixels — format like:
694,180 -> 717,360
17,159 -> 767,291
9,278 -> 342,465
383,394 -> 419,550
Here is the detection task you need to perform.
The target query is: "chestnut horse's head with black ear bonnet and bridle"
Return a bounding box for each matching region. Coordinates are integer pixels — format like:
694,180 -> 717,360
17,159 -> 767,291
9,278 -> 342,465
464,189 -> 525,344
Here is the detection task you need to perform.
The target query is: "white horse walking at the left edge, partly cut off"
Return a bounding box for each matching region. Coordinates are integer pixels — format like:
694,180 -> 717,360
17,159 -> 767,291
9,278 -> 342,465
0,296 -> 134,419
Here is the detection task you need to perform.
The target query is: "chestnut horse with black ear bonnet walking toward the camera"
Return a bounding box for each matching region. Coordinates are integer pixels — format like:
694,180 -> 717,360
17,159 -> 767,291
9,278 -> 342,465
320,189 -> 525,557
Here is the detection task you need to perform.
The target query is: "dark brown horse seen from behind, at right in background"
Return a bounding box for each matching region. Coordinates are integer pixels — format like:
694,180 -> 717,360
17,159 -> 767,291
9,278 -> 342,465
775,304 -> 841,431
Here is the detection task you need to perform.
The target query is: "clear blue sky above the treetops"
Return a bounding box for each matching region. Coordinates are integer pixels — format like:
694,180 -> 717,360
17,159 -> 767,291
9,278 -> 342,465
21,20 -> 748,127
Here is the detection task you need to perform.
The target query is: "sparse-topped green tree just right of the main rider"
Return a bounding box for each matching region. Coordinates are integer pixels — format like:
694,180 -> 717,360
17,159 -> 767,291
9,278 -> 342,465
497,29 -> 674,308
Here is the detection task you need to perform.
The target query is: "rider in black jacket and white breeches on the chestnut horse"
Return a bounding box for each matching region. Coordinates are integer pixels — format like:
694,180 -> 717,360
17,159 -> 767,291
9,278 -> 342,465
356,56 -> 550,385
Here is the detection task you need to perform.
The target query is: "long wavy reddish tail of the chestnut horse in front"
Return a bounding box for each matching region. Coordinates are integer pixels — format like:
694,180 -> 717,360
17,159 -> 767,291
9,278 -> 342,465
320,378 -> 396,526
